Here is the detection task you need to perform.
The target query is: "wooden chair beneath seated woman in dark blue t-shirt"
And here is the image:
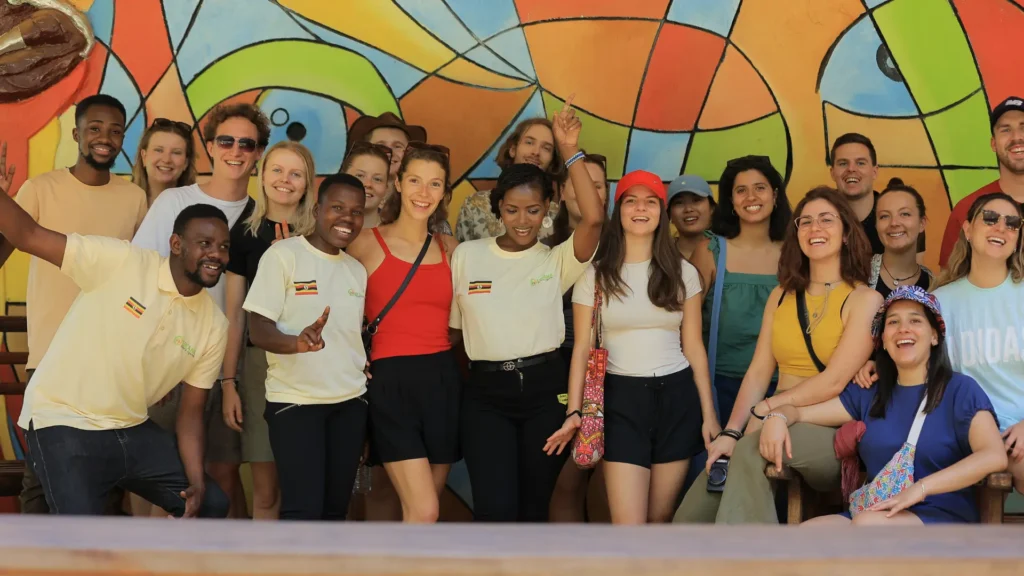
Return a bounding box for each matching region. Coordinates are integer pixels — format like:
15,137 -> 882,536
765,464 -> 1014,524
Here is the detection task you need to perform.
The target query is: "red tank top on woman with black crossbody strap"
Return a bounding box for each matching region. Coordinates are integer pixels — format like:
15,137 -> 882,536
365,229 -> 453,360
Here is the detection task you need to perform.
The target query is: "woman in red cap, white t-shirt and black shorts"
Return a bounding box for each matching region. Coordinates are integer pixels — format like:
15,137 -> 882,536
547,170 -> 720,524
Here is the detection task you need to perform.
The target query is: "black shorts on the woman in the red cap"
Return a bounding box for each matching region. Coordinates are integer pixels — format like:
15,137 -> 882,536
604,368 -> 705,468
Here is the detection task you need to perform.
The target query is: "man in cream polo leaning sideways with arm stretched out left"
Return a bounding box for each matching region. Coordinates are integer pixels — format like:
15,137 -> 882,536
0,166 -> 228,517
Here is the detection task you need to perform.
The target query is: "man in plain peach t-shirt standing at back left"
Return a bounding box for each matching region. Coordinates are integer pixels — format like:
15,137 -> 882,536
0,94 -> 146,513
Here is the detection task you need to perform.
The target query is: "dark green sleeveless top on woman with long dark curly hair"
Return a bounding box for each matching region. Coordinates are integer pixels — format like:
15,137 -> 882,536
702,233 -> 778,378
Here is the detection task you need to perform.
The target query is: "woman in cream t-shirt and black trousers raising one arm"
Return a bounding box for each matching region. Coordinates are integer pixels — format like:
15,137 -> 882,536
450,97 -> 604,522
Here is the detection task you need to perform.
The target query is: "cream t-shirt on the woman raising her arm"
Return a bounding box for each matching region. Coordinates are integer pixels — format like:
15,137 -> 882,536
449,231 -> 588,362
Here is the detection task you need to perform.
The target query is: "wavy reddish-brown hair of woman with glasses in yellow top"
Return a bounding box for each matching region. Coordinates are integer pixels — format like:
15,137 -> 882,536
778,186 -> 871,292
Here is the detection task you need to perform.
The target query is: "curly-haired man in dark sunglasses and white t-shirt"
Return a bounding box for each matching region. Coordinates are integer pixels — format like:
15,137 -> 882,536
132,104 -> 270,517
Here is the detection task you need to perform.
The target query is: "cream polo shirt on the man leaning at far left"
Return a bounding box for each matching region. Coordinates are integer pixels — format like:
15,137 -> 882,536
17,234 -> 227,430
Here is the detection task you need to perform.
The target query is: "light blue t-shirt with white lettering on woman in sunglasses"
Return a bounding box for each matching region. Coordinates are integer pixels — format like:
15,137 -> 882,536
935,275 -> 1024,431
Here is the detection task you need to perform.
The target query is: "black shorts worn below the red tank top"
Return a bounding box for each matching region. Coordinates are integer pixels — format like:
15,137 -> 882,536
367,351 -> 462,464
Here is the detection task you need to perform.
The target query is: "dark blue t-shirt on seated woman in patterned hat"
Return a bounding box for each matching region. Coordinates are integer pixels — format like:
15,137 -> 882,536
839,373 -> 994,524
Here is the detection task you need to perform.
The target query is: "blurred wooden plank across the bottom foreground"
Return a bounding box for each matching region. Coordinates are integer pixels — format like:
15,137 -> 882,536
0,517 -> 1024,576
